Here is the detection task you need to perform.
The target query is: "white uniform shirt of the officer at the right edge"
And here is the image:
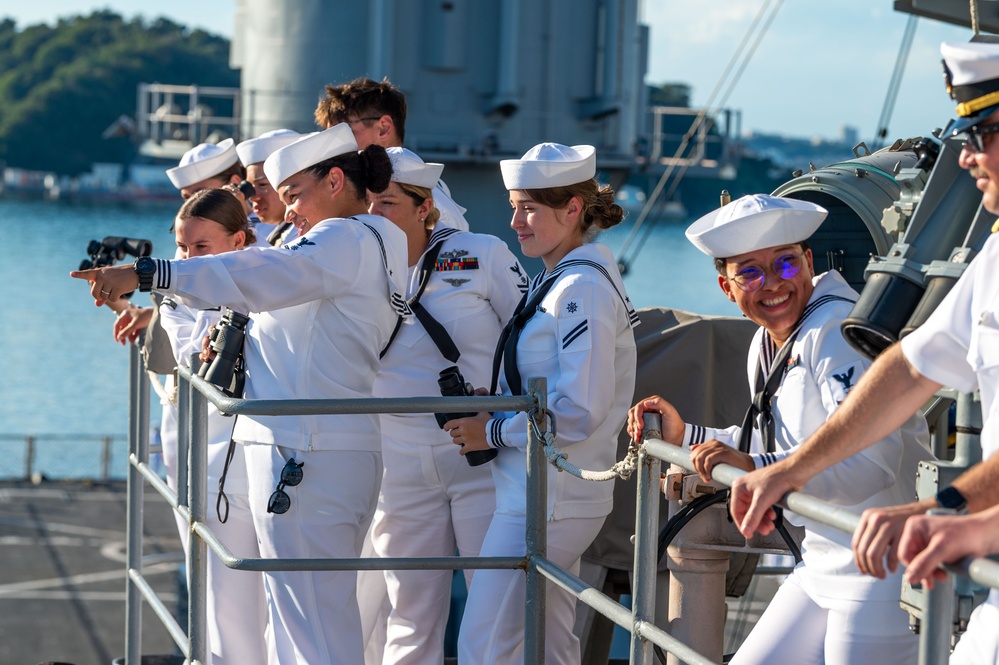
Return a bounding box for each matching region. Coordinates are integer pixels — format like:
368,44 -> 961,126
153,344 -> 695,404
902,234 -> 999,459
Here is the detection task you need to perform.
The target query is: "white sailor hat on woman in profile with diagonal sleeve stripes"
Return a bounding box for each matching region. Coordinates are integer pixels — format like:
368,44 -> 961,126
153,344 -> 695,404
500,143 -> 597,190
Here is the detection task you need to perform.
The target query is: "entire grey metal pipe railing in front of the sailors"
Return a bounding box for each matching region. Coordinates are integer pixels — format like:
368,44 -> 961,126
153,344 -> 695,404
125,340 -> 999,665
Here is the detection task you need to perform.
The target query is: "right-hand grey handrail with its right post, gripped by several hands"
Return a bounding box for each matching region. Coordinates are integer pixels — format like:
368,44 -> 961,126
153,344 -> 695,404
636,413 -> 999,665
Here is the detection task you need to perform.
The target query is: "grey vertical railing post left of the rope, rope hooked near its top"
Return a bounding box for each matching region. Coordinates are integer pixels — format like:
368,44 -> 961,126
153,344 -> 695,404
524,378 -> 548,665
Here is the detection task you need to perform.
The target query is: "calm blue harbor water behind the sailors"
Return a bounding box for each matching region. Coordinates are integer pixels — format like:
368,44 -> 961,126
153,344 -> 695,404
0,200 -> 738,479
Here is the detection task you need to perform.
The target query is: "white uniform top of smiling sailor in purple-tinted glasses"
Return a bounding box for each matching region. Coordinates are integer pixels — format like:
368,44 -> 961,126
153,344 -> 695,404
683,271 -> 932,598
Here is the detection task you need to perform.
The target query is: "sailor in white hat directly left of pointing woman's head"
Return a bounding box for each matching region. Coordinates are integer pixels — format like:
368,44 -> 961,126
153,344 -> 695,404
234,129 -> 302,246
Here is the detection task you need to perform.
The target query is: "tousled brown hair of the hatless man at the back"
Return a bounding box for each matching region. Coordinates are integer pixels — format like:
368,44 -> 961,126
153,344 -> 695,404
315,77 -> 406,141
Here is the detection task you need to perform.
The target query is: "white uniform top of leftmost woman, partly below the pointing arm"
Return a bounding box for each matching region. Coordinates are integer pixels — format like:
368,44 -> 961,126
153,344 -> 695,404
160,298 -> 246,493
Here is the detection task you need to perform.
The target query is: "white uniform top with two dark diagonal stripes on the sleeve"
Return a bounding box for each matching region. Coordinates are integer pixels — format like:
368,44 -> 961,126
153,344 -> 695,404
486,243 -> 638,520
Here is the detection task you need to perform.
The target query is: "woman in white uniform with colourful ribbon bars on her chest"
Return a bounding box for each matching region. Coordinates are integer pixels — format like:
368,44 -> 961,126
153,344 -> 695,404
359,148 -> 528,665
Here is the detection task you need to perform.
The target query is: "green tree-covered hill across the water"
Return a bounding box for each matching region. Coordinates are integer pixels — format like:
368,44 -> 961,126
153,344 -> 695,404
0,11 -> 239,175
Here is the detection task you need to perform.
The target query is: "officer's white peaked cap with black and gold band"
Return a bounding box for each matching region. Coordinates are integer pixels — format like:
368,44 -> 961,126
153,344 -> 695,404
940,41 -> 999,137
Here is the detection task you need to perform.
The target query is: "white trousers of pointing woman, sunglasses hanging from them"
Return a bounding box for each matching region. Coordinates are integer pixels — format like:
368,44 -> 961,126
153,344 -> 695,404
244,443 -> 382,665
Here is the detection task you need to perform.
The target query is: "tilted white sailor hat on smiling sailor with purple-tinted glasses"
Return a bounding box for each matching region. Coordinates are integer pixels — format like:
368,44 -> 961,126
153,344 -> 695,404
686,194 -> 828,259
